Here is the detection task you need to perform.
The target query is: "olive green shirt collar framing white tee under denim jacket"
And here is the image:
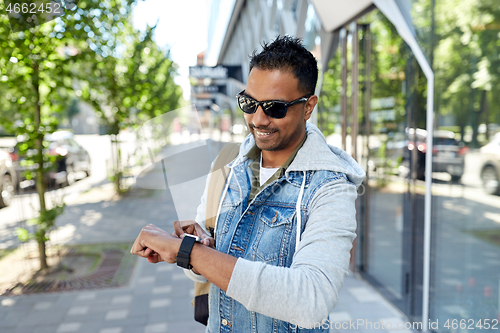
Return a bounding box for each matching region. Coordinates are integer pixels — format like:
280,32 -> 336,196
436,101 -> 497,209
245,133 -> 307,205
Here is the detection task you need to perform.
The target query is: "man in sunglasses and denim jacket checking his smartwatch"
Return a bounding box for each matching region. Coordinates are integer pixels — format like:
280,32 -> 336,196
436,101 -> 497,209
132,37 -> 365,333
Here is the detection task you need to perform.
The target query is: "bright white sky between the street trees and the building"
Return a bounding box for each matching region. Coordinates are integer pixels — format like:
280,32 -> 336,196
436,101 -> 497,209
133,0 -> 209,100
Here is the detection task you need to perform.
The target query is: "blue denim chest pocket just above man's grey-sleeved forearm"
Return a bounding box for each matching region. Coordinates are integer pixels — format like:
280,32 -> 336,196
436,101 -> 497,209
253,206 -> 295,266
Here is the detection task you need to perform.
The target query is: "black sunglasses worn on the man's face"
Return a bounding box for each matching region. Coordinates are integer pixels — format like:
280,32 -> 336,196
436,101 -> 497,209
236,89 -> 312,119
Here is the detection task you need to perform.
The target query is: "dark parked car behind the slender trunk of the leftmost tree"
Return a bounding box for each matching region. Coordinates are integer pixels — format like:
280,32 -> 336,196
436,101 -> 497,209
10,131 -> 91,188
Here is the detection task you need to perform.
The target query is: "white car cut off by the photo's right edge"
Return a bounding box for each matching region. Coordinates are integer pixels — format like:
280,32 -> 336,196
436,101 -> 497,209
479,133 -> 500,194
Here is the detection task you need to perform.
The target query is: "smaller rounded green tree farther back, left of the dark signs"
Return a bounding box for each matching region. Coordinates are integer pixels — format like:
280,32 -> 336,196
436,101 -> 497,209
75,21 -> 182,192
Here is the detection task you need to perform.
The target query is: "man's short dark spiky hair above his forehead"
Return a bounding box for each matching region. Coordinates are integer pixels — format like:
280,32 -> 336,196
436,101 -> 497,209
249,36 -> 318,95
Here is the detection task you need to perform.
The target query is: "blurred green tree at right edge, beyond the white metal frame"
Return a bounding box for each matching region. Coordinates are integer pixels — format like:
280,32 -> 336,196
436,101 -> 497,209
434,0 -> 500,146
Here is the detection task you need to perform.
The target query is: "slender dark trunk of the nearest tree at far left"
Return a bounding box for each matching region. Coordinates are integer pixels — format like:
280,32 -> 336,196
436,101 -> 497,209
33,62 -> 49,270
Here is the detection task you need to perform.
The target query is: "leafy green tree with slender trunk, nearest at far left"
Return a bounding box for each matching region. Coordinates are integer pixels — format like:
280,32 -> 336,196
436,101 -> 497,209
0,0 -> 148,269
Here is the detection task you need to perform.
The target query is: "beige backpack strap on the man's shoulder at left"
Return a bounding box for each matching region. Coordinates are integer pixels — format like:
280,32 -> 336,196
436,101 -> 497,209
205,143 -> 241,232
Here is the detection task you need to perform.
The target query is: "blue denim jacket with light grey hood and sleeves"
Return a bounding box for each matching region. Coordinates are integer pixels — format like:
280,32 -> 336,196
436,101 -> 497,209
188,123 -> 365,333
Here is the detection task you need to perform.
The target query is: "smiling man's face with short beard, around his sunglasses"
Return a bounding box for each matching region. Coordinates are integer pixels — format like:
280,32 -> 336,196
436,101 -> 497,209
244,67 -> 317,151
